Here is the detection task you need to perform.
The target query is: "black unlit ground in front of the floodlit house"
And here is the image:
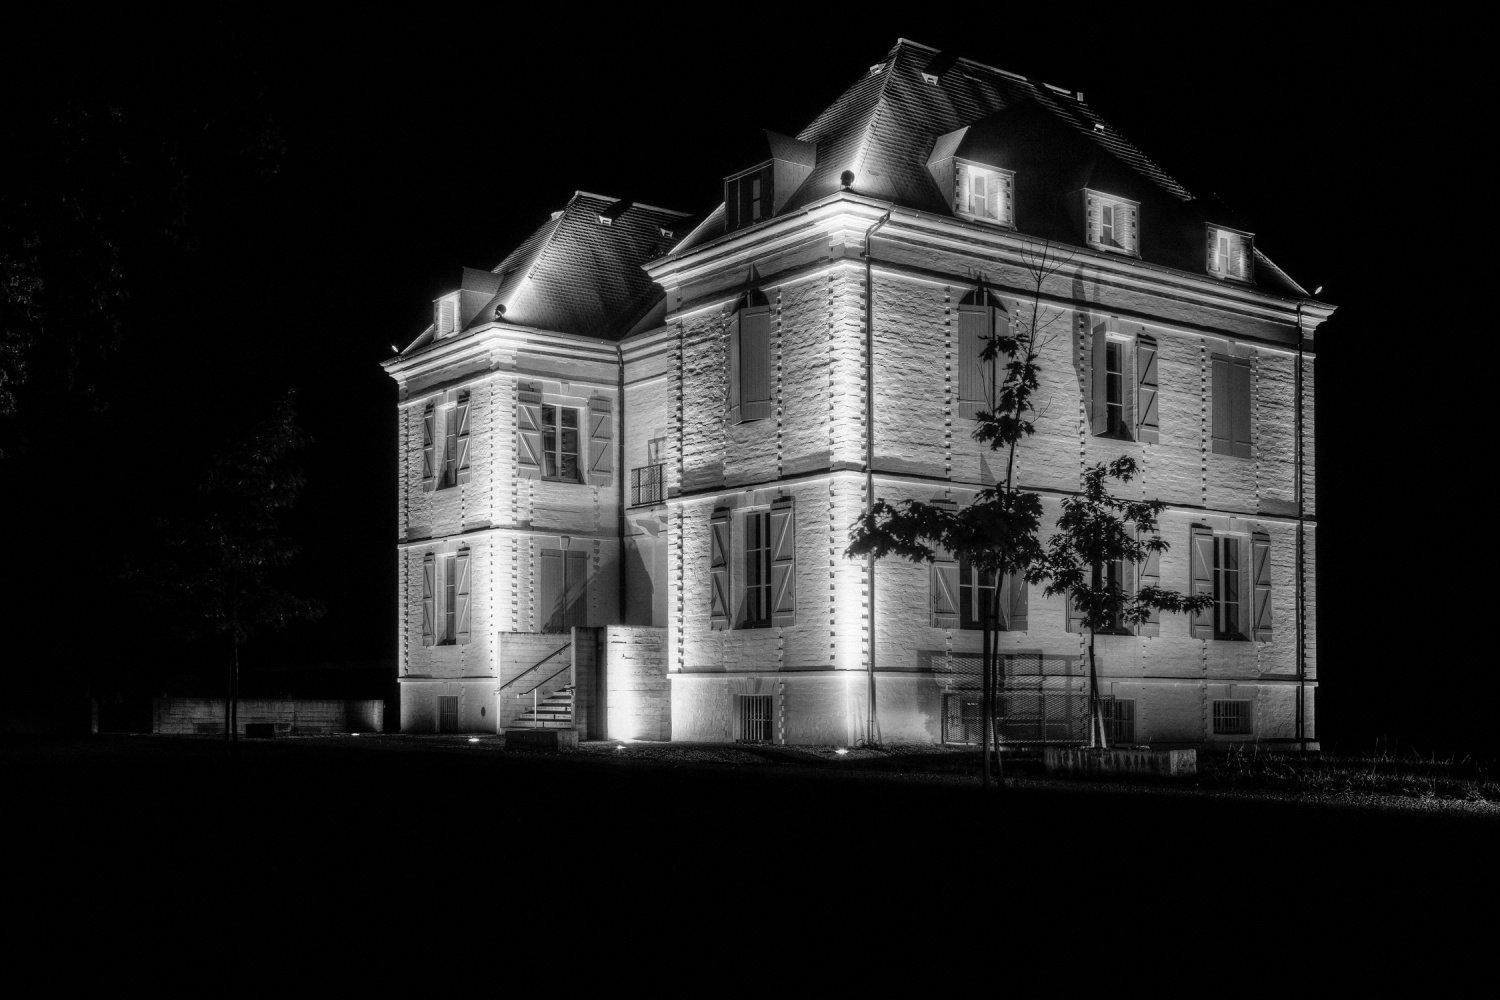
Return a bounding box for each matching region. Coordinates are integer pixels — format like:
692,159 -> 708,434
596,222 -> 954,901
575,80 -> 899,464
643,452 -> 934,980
0,736 -> 1500,993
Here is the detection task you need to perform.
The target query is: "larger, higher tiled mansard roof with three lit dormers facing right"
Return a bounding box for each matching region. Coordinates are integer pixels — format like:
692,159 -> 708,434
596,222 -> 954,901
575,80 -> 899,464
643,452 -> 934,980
674,39 -> 1307,294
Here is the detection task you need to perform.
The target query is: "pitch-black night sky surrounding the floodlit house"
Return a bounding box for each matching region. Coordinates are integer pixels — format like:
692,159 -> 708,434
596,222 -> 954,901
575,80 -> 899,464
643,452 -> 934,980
0,11 -> 1476,745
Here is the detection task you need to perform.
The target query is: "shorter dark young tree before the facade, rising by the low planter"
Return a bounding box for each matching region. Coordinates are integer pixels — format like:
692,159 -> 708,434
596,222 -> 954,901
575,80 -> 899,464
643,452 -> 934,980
1028,456 -> 1214,748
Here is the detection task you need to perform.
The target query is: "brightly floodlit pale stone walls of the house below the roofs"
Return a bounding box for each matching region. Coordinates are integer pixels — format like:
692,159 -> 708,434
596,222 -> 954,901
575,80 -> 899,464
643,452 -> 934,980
387,45 -> 1332,744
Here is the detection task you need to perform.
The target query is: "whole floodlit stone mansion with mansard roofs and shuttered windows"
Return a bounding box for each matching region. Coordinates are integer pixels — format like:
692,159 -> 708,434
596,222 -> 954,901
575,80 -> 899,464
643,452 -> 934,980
386,39 -> 1332,745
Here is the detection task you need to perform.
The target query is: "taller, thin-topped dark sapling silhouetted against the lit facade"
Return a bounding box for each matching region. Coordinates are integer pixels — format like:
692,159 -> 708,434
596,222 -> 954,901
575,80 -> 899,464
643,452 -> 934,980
846,243 -> 1071,787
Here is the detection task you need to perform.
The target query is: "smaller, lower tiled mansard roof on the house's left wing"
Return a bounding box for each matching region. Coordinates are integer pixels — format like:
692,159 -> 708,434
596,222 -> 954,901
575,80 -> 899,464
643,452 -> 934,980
402,190 -> 689,354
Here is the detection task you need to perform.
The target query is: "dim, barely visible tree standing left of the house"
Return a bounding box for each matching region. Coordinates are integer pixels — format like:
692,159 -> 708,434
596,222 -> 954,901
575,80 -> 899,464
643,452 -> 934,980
141,393 -> 323,739
